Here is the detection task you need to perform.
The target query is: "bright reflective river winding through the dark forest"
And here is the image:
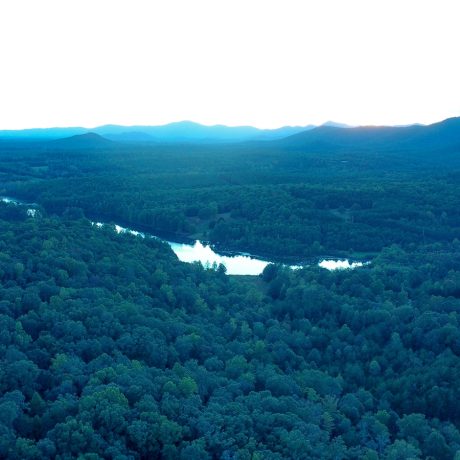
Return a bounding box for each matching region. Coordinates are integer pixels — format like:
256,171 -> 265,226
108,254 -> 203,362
0,196 -> 369,275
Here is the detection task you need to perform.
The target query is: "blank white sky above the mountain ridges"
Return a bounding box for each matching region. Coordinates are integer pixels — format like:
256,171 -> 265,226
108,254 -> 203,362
0,0 -> 460,129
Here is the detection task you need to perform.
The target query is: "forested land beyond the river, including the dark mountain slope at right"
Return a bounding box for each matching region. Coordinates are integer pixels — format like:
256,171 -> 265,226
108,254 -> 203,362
0,119 -> 460,262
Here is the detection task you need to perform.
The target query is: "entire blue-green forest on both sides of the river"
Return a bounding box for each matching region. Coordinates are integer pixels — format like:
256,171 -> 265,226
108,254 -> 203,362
0,120 -> 460,460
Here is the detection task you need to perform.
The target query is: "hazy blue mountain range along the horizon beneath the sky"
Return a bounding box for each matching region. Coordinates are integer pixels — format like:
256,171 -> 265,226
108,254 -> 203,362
0,117 -> 460,161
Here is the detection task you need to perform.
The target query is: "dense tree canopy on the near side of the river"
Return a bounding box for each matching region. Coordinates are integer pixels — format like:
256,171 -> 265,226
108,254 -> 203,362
0,203 -> 460,460
